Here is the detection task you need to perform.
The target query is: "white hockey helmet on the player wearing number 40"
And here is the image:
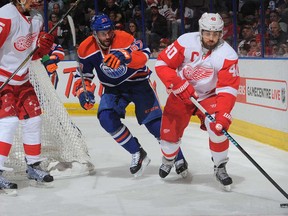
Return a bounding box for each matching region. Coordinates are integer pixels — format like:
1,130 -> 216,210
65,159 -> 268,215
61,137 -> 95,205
199,12 -> 224,34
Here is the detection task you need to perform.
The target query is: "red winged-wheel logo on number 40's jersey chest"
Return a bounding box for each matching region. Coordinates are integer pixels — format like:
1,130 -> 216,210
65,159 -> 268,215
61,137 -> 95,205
182,65 -> 213,81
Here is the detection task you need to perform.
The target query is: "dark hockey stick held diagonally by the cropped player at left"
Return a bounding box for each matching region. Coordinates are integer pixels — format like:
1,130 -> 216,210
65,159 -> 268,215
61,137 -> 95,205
0,0 -> 82,91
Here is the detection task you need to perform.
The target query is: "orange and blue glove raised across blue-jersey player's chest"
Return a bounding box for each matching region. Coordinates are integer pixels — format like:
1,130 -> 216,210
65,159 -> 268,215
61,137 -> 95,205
103,49 -> 132,69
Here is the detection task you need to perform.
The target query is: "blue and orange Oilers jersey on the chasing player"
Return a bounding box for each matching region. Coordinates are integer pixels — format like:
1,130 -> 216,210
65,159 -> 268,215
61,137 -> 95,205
75,30 -> 151,87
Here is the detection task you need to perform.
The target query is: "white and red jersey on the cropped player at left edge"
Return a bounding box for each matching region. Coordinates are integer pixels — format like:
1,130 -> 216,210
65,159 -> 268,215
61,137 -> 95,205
0,3 -> 43,85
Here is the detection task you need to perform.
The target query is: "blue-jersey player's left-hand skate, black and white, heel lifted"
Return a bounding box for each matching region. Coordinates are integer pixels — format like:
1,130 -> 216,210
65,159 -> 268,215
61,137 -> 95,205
130,147 -> 151,177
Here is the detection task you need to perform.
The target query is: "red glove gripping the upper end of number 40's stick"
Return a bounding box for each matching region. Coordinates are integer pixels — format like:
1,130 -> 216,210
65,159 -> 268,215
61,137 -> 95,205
172,80 -> 198,105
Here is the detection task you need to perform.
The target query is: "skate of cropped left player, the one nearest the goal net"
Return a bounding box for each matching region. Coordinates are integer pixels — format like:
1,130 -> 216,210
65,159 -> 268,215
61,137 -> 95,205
26,162 -> 54,187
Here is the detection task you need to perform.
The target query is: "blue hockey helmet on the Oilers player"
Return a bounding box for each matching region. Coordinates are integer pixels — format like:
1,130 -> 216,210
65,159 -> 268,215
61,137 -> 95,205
90,14 -> 114,32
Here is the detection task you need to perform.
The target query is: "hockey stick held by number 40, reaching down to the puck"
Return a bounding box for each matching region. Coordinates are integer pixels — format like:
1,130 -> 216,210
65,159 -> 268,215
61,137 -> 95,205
190,97 -> 288,208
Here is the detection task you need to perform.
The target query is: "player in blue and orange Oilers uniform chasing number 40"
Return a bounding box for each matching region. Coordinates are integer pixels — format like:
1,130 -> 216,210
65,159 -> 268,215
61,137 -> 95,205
74,14 -> 188,177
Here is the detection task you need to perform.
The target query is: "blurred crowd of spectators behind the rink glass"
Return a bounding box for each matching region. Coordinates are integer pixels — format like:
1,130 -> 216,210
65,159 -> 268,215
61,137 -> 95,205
0,0 -> 288,60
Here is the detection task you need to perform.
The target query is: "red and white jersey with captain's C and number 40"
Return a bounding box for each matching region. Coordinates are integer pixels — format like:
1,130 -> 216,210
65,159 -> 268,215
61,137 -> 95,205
155,32 -> 240,105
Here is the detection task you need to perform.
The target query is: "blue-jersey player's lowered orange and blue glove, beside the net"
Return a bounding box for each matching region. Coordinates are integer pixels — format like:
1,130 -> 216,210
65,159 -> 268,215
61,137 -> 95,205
76,80 -> 95,110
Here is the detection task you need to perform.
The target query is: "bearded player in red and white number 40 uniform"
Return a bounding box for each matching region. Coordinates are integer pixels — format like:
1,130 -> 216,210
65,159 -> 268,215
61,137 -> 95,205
155,13 -> 240,190
